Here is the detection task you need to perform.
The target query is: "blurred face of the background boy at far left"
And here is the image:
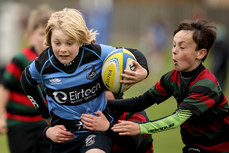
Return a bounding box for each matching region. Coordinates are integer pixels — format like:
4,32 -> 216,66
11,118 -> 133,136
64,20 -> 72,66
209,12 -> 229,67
29,26 -> 47,55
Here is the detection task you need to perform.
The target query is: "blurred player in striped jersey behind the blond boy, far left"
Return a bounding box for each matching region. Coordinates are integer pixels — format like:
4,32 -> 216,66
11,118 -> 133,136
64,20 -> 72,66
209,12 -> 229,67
0,5 -> 53,153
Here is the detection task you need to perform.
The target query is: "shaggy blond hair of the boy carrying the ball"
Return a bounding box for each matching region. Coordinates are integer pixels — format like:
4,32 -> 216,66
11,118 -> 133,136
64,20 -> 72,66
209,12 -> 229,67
45,8 -> 98,46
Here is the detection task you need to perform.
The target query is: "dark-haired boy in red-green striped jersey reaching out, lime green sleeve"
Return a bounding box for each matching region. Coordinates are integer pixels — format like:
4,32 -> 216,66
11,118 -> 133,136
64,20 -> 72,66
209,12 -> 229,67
108,20 -> 229,153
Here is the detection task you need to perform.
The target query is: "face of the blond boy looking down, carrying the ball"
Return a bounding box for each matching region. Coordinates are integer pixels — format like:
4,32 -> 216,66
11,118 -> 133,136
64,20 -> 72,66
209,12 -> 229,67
51,29 -> 80,64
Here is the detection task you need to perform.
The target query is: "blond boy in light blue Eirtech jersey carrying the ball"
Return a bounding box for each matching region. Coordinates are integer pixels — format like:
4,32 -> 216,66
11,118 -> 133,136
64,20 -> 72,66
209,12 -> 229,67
21,9 -> 148,153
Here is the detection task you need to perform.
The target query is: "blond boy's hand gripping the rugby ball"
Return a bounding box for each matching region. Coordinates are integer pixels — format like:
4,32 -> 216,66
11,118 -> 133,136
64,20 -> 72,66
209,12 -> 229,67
120,61 -> 147,89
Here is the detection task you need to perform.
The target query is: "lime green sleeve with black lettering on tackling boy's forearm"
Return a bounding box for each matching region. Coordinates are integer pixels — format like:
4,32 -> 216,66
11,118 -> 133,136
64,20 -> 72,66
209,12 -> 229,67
140,109 -> 192,134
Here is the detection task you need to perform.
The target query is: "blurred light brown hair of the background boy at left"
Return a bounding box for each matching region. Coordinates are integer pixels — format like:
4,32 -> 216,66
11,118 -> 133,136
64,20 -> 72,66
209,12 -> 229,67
27,5 -> 54,33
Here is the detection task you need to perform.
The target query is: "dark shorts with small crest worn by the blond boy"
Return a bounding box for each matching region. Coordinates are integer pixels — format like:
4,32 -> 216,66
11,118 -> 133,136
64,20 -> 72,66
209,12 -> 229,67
51,131 -> 112,153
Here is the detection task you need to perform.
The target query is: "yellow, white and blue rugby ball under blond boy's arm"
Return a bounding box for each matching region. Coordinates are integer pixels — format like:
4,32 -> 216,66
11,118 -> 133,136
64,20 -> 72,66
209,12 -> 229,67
101,48 -> 136,93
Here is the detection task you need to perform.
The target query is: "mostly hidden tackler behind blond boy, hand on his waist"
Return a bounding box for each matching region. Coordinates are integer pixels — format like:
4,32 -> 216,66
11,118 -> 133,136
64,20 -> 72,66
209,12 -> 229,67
81,90 -> 153,153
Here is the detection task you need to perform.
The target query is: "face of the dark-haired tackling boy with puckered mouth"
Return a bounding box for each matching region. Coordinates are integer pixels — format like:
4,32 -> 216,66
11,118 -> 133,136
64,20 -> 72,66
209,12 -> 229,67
172,30 -> 201,72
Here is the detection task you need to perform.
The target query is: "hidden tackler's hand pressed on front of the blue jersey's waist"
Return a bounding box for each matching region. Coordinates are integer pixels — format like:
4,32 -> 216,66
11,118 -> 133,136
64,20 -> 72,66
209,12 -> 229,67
81,110 -> 110,131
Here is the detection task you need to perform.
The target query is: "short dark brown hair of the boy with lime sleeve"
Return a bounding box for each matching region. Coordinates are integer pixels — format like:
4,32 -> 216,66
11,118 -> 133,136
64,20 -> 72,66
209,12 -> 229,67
174,19 -> 216,61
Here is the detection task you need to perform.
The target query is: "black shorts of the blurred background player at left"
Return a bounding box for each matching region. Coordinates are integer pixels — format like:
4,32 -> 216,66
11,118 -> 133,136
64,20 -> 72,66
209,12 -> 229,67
7,122 -> 50,153
